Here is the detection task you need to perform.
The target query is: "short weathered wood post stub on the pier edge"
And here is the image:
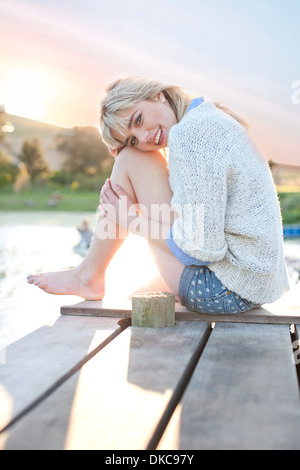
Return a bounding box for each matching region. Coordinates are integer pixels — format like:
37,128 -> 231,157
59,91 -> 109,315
132,292 -> 175,328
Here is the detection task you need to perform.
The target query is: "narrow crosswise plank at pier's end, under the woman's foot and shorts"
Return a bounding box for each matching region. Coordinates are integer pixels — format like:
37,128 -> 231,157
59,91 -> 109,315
61,299 -> 300,325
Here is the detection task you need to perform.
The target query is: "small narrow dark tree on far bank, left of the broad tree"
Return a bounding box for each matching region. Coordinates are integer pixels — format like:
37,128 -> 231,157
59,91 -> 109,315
19,137 -> 49,182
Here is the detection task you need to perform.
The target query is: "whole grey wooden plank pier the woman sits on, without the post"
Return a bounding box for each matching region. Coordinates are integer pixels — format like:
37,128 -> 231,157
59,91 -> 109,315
0,292 -> 300,450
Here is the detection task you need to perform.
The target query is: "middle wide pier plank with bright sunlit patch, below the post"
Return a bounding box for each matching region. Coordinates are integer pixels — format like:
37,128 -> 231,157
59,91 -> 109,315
0,323 -> 209,450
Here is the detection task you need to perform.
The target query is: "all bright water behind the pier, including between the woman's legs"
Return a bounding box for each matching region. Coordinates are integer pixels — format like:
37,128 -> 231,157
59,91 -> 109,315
0,212 -> 300,361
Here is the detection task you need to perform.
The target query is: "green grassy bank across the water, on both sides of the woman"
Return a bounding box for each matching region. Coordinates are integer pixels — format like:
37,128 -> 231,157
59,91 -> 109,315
0,187 -> 300,224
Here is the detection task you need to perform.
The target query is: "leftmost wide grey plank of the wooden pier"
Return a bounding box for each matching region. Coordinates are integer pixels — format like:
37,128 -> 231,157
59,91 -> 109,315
0,317 -> 128,431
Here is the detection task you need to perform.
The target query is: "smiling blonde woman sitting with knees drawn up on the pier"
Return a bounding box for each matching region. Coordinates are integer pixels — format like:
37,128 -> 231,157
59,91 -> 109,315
28,77 -> 289,313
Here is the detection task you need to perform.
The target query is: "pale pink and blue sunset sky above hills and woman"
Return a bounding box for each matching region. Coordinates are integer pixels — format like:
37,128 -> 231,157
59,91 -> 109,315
0,0 -> 300,165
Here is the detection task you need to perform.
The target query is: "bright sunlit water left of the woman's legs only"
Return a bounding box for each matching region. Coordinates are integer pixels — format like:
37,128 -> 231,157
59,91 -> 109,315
0,212 -> 94,354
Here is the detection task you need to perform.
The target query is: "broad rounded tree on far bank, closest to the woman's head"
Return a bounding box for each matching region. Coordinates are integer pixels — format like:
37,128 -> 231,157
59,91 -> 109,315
56,126 -> 112,176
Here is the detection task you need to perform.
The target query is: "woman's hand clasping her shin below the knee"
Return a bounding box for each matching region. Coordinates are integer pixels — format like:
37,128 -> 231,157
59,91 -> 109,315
100,179 -> 138,228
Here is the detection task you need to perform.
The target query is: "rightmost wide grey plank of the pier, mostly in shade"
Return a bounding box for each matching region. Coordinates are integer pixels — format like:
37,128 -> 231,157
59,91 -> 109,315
159,324 -> 300,450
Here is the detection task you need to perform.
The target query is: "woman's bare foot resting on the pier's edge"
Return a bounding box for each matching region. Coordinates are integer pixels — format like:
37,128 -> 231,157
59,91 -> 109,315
27,267 -> 104,300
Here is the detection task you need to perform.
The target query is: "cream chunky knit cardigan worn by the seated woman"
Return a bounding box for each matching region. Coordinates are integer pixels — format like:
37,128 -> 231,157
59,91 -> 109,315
169,101 -> 289,304
